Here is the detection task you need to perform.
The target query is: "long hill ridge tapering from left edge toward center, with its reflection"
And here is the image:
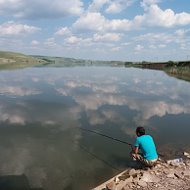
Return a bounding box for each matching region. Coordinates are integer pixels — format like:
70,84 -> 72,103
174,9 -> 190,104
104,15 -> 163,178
0,51 -> 125,69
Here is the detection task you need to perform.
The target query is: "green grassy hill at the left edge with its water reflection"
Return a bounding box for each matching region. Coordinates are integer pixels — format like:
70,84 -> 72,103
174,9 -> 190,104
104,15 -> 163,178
0,51 -> 46,69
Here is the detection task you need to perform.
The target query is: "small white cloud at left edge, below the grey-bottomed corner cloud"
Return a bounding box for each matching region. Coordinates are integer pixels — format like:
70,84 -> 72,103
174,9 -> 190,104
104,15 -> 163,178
0,21 -> 40,36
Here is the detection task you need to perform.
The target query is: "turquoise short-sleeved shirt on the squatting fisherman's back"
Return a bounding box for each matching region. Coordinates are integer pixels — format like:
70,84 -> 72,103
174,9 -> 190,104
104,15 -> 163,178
135,135 -> 158,160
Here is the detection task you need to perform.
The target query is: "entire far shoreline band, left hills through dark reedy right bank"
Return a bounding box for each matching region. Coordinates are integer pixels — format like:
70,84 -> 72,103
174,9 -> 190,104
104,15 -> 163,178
0,51 -> 190,81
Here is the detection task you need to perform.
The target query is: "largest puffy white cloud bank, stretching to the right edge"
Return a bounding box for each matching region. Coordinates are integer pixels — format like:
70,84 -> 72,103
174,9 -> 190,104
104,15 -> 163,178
73,4 -> 190,32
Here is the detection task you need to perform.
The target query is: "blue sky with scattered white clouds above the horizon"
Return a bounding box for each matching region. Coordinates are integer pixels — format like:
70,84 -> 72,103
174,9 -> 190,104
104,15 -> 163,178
0,0 -> 190,61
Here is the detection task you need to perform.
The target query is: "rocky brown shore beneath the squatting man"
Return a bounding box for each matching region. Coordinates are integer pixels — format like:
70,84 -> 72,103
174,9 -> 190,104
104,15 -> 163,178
93,152 -> 190,190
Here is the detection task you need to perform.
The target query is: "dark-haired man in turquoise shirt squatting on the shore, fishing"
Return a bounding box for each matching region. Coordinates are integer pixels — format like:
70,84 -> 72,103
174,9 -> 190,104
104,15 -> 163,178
132,127 -> 158,167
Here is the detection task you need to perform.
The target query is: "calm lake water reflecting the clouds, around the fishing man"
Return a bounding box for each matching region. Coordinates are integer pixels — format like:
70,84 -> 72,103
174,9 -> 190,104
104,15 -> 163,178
0,67 -> 190,190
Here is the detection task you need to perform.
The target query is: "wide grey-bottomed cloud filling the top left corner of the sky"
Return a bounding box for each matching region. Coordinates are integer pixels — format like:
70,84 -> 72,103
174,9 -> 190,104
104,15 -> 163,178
0,0 -> 83,19
